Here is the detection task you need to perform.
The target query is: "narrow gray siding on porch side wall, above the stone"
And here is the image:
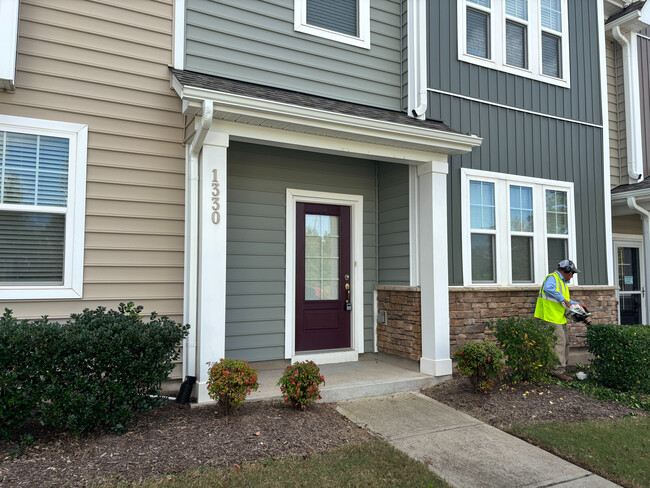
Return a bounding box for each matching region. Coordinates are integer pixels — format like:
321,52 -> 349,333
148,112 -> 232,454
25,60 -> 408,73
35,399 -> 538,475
377,163 -> 410,285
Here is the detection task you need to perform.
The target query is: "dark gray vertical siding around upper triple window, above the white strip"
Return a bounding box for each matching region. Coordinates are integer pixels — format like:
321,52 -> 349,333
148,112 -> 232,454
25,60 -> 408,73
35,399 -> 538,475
427,0 -> 602,126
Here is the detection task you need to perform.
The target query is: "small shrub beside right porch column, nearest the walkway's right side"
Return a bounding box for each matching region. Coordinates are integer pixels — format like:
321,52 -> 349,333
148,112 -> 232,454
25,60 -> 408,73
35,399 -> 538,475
454,341 -> 505,393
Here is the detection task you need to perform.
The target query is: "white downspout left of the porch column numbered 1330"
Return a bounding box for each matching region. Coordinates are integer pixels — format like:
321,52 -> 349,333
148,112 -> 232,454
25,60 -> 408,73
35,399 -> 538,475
183,100 -> 213,378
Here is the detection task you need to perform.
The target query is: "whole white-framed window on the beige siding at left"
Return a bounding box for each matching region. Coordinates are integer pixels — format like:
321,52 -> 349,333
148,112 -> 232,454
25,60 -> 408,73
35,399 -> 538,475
0,115 -> 88,299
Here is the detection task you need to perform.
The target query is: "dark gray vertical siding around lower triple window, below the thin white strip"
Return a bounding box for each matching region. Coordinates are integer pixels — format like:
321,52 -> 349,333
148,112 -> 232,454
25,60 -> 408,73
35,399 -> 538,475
438,90 -> 606,285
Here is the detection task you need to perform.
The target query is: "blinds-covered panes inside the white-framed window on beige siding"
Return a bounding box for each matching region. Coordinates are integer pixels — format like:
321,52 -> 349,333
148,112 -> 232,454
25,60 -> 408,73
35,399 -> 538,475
0,131 -> 70,285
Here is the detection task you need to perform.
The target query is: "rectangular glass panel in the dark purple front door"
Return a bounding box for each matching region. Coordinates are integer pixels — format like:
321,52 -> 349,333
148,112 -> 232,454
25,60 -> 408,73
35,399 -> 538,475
305,214 -> 339,300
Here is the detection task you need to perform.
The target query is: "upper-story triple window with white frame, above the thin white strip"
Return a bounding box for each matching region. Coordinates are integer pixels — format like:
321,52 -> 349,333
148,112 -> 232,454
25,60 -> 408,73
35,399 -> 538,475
458,0 -> 569,88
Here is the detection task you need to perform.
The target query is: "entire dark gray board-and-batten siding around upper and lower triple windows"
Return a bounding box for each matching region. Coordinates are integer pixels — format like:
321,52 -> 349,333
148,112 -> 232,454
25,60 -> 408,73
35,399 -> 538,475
427,0 -> 607,285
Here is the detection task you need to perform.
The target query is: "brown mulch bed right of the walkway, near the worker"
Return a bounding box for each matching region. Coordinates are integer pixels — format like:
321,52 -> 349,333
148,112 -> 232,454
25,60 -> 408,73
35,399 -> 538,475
422,375 -> 645,429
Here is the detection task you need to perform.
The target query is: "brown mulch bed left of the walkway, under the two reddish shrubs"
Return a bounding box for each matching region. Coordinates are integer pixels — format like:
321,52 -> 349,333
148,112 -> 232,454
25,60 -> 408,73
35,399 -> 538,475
0,402 -> 372,488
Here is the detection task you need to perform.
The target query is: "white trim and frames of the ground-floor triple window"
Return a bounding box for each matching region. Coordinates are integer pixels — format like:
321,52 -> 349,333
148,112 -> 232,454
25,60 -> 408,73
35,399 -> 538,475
461,168 -> 578,287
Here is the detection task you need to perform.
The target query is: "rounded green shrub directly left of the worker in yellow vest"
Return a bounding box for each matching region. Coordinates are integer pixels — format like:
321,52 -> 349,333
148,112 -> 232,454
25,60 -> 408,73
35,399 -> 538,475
488,317 -> 558,383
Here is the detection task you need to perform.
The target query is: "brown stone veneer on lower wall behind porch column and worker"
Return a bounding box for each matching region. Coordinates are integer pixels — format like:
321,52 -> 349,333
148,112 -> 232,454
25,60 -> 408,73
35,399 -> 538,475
376,285 -> 618,360
